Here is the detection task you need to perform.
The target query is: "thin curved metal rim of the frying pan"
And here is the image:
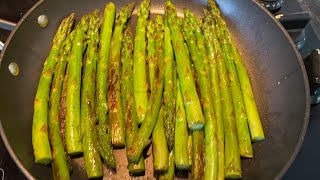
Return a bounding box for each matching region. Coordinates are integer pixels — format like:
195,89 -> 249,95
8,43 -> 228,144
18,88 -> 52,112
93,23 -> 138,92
0,0 -> 310,179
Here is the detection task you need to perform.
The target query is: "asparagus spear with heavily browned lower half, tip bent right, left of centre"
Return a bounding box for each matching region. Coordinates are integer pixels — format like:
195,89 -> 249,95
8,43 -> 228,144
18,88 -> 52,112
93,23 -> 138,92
108,3 -> 134,147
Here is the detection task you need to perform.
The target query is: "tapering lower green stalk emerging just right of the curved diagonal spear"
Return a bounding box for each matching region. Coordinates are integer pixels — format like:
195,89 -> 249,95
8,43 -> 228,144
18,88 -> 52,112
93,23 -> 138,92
152,106 -> 169,171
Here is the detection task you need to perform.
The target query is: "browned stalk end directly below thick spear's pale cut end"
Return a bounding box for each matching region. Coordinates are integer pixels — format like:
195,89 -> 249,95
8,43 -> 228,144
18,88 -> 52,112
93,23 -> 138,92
191,130 -> 205,180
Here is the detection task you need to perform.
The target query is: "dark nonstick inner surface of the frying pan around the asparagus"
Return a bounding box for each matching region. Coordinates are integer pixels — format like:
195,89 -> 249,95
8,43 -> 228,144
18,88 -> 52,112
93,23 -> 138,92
0,0 -> 309,179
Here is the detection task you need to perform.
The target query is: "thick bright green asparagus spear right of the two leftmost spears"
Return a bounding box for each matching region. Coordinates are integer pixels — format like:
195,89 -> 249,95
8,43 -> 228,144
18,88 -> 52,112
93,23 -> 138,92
66,15 -> 88,155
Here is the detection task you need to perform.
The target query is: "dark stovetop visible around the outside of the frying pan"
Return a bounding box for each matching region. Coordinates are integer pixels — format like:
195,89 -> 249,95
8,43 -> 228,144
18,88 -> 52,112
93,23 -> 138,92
0,0 -> 320,180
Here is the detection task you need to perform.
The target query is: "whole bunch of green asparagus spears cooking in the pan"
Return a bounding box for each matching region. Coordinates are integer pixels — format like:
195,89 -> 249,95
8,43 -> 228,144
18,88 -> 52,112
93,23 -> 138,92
32,0 -> 264,180
